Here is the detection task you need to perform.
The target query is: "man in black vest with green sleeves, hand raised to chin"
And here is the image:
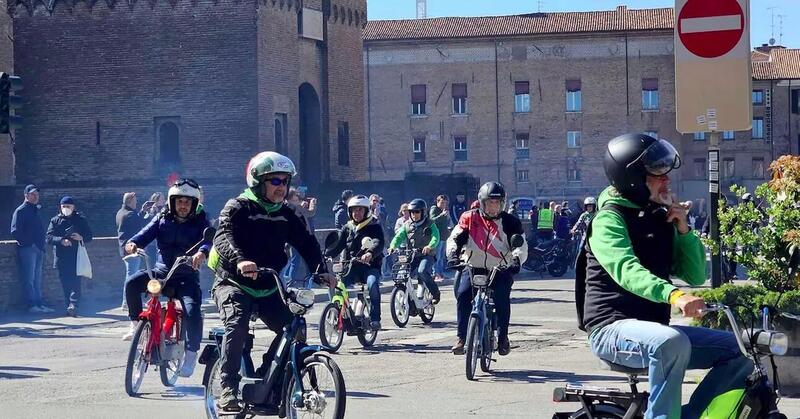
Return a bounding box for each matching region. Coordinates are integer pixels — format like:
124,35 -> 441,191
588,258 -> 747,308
575,134 -> 753,418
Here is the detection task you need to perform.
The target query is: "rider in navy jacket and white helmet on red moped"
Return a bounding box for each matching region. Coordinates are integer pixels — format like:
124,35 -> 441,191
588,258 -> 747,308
123,179 -> 211,377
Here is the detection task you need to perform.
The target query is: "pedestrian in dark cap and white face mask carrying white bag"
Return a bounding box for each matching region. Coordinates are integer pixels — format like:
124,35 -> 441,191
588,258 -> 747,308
46,196 -> 92,317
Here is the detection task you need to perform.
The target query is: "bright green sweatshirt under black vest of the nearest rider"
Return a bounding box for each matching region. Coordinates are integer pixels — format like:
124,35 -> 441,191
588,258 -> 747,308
589,186 -> 706,303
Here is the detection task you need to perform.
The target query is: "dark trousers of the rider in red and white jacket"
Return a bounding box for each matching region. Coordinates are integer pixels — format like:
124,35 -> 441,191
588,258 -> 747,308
456,271 -> 514,340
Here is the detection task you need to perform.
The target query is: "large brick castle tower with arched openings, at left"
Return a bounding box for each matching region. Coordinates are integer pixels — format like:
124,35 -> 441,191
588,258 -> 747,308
0,0 -> 367,234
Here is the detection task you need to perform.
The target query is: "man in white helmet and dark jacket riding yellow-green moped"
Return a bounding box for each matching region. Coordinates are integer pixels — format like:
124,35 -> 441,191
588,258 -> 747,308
325,195 -> 384,330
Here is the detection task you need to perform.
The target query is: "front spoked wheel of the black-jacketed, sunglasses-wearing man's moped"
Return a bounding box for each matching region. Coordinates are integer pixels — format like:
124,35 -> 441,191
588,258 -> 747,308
285,355 -> 347,419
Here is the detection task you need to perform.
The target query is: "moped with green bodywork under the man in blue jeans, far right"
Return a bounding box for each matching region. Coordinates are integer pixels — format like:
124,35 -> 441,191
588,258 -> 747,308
552,304 -> 800,419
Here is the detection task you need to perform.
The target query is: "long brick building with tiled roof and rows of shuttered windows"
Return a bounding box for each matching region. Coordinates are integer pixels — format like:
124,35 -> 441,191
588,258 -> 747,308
364,6 -> 800,212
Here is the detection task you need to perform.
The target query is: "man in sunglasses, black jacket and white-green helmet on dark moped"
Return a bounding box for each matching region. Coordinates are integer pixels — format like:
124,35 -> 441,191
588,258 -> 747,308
209,151 -> 332,411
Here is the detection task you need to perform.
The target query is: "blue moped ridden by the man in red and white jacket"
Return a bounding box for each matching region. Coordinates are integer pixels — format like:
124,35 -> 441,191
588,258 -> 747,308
456,234 -> 525,381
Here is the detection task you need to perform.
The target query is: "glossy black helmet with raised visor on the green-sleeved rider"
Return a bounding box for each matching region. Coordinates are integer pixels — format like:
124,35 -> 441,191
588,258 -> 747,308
603,134 -> 681,206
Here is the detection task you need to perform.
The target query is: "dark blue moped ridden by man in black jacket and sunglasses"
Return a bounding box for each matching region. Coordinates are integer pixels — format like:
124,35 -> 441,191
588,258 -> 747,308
199,268 -> 347,419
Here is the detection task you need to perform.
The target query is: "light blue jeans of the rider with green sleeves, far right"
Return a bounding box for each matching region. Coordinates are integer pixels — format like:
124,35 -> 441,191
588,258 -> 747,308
589,319 -> 753,419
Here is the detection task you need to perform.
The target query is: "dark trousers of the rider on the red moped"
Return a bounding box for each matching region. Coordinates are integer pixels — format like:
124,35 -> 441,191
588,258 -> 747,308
125,264 -> 203,352
